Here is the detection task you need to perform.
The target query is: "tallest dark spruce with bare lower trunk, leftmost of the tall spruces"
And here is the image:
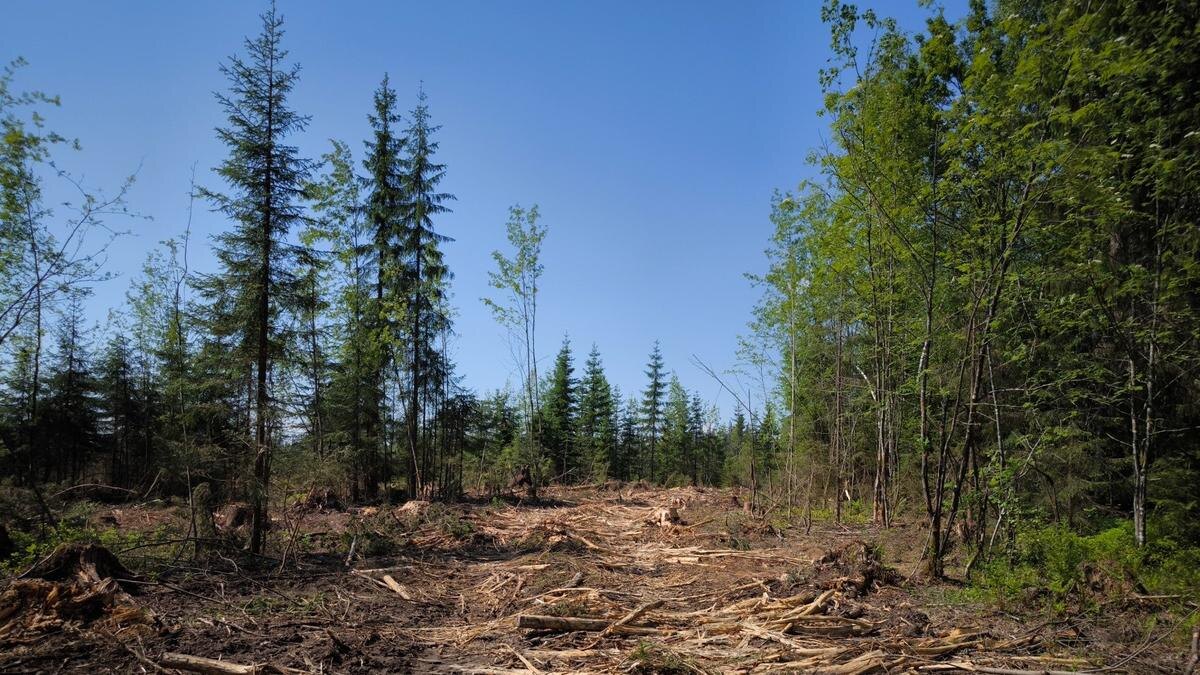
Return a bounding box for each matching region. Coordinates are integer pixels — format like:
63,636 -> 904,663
202,4 -> 310,552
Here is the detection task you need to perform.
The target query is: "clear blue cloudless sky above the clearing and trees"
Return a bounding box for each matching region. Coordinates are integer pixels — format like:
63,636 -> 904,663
0,0 -> 965,412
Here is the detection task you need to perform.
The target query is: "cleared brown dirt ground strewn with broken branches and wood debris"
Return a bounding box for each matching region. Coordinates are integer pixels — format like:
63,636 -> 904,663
0,485 -> 1188,674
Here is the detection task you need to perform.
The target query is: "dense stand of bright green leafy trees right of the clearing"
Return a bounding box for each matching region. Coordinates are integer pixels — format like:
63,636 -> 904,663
750,0 -> 1200,574
